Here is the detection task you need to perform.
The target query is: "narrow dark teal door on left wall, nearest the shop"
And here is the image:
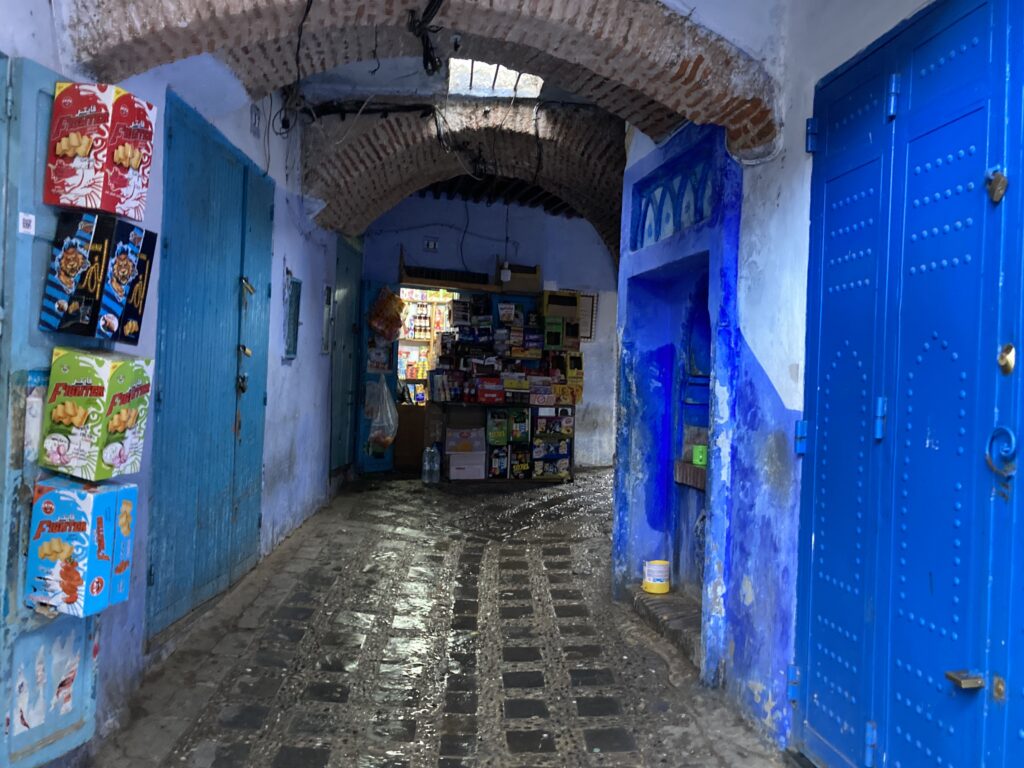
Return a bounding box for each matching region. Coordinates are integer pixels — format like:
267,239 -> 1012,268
331,238 -> 362,472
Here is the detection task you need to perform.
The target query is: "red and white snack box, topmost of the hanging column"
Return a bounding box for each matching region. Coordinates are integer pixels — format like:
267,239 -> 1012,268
43,83 -> 157,220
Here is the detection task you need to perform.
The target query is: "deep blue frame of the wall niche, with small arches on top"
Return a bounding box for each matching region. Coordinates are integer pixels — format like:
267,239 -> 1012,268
612,126 -> 741,684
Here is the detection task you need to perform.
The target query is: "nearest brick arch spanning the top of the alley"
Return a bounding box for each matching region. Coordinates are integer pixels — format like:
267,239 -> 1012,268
65,0 -> 778,158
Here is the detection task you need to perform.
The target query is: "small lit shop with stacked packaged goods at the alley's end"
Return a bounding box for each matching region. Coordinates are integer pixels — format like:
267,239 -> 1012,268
394,274 -> 594,482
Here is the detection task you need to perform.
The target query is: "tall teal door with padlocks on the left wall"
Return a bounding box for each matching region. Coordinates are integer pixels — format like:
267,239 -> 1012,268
146,94 -> 273,635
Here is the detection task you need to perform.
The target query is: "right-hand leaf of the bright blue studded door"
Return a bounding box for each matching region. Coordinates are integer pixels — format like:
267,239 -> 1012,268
880,2 -> 1008,768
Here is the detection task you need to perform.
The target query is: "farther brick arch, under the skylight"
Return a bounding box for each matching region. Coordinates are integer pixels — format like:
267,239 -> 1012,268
302,101 -> 626,261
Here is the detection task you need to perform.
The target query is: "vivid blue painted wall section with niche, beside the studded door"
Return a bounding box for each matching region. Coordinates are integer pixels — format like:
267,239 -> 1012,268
612,126 -> 799,745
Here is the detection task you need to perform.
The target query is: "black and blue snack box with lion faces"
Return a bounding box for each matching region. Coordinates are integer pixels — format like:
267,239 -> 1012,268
39,211 -> 157,344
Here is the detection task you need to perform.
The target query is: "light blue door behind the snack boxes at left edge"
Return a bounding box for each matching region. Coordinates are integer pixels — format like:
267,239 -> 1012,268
0,55 -> 98,768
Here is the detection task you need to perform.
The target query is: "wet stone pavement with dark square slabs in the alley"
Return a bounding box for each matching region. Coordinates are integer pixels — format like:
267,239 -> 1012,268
92,472 -> 780,768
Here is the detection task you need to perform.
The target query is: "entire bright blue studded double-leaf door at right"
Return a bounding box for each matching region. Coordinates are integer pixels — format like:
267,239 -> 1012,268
791,0 -> 1024,768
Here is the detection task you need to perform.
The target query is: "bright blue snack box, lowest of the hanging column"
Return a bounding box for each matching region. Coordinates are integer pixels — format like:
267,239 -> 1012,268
25,477 -> 138,616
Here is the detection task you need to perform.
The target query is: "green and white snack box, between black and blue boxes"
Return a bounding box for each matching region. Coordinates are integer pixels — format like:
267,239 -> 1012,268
39,347 -> 153,480
